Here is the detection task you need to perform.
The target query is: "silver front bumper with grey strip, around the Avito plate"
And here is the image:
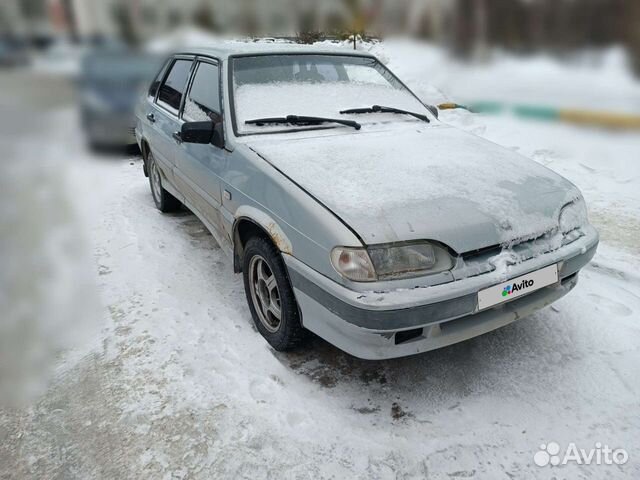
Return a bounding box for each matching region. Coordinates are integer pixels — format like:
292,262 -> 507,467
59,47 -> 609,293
284,227 -> 598,359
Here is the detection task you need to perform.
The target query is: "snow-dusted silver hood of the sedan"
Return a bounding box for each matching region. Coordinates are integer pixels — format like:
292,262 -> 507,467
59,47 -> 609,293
248,122 -> 580,253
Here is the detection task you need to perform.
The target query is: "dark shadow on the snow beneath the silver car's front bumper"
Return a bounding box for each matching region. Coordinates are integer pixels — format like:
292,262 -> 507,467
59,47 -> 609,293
274,308 -> 581,420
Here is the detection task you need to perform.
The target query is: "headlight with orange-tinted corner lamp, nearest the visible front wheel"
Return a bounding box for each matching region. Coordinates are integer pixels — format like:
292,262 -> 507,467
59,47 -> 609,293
331,242 -> 453,282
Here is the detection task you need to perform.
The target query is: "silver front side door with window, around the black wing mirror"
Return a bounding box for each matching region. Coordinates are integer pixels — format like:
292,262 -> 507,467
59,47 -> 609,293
176,58 -> 229,237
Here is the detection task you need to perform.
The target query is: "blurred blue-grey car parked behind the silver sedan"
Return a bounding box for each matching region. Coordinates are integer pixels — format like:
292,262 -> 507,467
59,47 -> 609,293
78,50 -> 162,149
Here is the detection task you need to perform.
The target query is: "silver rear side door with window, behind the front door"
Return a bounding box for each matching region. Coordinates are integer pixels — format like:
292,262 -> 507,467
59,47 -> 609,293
146,57 -> 193,186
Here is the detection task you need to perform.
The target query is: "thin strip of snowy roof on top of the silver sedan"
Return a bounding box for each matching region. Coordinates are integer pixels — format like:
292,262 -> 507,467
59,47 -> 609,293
175,42 -> 373,61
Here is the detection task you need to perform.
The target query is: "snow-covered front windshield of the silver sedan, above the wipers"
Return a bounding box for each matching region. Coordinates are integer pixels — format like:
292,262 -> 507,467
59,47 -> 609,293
232,54 -> 427,134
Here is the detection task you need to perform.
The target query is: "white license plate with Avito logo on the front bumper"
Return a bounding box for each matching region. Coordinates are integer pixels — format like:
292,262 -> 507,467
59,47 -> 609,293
478,265 -> 558,310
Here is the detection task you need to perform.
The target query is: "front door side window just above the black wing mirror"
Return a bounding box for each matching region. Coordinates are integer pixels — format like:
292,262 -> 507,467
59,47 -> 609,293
182,63 -> 220,122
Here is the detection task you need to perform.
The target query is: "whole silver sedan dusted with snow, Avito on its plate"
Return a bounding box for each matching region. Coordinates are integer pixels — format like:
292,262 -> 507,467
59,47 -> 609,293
136,45 -> 598,359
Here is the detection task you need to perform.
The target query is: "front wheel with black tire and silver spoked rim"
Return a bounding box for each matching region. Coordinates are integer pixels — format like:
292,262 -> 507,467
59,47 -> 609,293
242,237 -> 306,352
